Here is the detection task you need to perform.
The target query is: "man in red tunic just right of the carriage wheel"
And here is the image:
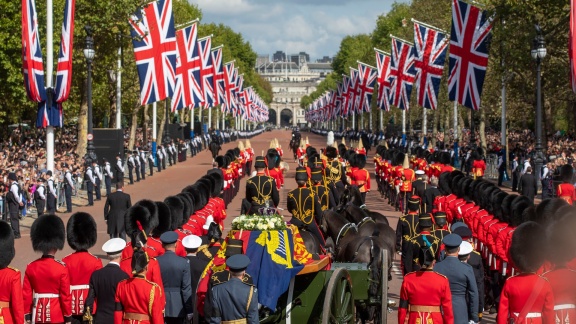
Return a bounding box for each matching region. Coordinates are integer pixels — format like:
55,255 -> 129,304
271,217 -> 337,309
398,247 -> 454,324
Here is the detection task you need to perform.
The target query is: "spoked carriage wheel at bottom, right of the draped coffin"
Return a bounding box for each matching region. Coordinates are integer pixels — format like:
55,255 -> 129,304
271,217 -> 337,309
322,268 -> 356,324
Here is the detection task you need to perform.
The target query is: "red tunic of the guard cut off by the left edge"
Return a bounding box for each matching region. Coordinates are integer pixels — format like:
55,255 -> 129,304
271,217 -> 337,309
0,267 -> 24,324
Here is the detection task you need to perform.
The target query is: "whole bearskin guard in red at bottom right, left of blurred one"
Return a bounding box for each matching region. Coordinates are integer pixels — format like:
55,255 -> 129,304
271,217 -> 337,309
496,221 -> 555,324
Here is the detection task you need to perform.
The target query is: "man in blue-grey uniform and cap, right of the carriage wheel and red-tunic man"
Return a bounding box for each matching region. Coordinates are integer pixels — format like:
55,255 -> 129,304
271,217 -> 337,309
434,234 -> 479,324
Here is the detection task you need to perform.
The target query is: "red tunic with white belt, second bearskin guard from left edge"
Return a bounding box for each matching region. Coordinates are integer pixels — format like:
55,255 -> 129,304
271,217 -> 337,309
22,255 -> 72,323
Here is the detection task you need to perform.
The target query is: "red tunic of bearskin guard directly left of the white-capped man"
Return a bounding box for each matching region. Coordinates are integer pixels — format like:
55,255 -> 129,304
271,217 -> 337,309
62,251 -> 102,315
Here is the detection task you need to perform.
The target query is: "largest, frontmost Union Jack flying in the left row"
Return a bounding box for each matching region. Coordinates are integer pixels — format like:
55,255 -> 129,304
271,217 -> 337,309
129,0 -> 176,105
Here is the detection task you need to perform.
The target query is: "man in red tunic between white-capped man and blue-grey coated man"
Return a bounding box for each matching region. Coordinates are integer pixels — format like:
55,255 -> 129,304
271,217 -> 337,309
114,251 -> 164,324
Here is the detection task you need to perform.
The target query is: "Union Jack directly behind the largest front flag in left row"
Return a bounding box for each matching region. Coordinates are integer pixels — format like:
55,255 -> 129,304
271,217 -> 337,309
170,23 -> 204,112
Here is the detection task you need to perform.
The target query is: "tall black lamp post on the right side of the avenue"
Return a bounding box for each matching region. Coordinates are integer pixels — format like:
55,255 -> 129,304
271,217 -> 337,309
530,25 -> 546,191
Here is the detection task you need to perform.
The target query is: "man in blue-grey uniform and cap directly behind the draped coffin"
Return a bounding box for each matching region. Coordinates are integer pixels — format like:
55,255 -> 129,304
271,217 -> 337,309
206,254 -> 259,324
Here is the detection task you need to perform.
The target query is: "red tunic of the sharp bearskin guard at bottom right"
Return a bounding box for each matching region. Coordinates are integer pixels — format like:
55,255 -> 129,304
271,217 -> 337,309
496,273 -> 555,324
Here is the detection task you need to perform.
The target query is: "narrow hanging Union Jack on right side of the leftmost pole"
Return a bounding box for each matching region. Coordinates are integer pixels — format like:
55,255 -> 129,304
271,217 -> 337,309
49,0 -> 76,103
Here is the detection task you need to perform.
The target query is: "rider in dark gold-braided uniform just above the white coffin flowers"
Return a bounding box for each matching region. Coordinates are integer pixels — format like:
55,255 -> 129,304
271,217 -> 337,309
242,156 -> 280,214
